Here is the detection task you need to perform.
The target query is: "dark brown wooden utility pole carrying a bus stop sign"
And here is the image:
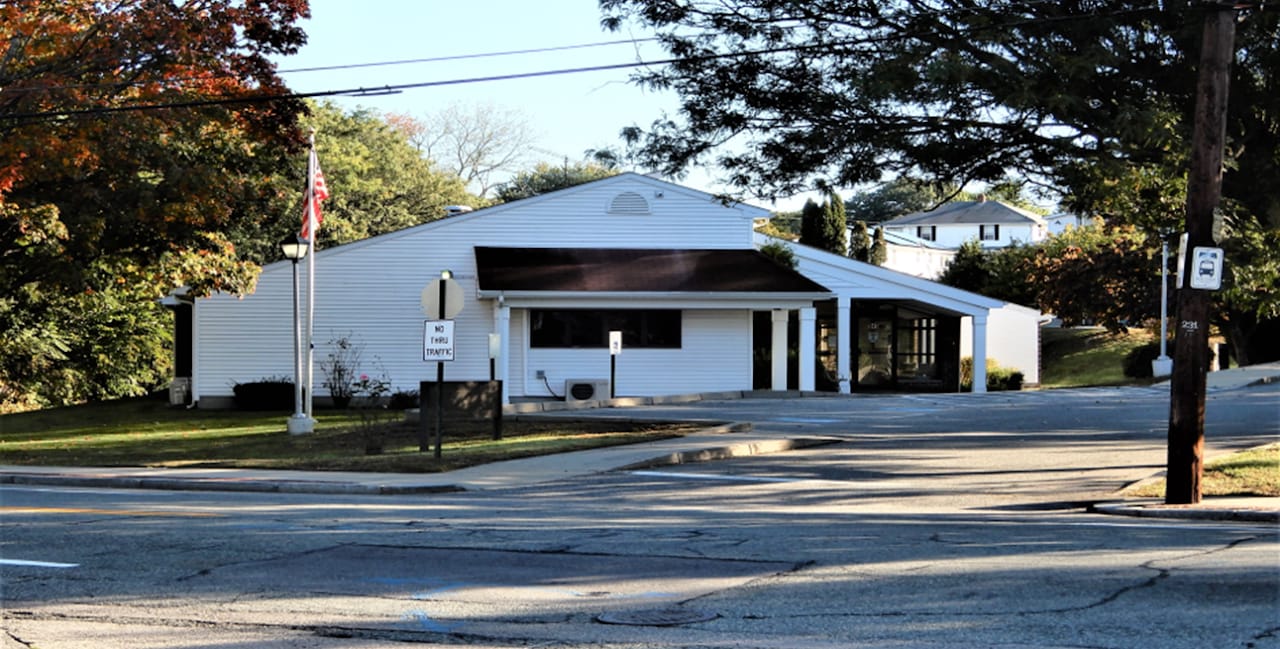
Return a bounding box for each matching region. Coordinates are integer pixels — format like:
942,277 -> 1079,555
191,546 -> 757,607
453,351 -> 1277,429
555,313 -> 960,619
1165,3 -> 1236,504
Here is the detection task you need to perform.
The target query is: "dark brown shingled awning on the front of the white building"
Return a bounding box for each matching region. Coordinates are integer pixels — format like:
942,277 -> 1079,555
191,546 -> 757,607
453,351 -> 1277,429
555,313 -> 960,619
475,247 -> 829,293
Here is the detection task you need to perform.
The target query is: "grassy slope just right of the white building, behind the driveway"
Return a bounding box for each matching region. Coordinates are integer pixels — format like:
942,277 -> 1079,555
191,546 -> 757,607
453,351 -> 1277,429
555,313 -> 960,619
1041,328 -> 1157,388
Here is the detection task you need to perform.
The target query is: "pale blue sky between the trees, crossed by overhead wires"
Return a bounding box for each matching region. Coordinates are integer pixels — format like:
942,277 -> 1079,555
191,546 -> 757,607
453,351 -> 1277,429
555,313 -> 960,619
272,0 -> 790,209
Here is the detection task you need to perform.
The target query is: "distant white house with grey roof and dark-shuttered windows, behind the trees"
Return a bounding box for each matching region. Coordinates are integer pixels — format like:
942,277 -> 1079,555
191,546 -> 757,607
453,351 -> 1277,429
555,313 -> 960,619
883,198 -> 1048,248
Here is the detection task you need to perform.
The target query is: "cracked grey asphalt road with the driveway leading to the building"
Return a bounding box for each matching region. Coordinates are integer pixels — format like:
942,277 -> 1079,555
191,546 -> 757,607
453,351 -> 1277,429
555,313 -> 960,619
0,387 -> 1280,649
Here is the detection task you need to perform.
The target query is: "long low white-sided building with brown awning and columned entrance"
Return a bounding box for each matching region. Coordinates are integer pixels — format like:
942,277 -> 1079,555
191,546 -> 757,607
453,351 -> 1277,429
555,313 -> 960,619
177,173 -> 1039,407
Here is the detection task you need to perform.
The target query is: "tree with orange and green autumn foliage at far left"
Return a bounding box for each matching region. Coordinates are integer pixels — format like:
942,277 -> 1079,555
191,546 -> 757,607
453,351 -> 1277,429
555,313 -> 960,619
0,0 -> 307,406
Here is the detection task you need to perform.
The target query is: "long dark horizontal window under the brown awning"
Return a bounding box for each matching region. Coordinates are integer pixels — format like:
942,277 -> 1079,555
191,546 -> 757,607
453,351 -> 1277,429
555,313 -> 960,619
529,308 -> 681,349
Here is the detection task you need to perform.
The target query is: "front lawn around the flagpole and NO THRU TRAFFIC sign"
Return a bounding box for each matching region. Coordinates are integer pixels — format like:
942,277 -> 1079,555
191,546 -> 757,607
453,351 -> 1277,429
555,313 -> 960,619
0,398 -> 695,472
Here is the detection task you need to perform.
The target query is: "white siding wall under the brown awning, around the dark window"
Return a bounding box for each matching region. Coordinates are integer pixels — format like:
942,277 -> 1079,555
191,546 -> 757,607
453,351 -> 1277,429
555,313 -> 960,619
511,310 -> 751,397
